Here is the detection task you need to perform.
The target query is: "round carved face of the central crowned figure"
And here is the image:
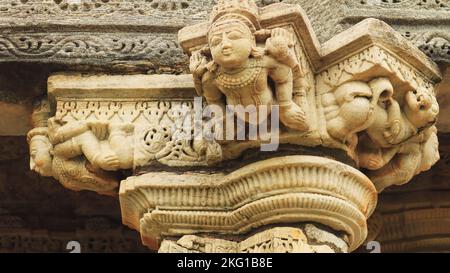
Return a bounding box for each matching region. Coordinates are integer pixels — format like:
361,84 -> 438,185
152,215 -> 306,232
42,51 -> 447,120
209,21 -> 255,69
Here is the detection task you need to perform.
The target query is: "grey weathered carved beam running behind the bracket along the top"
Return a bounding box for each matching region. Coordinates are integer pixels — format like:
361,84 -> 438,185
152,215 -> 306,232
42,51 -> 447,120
0,0 -> 444,71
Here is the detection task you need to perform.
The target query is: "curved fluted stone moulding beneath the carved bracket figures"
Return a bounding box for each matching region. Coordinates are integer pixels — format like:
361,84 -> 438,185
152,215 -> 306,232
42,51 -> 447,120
120,156 -> 377,250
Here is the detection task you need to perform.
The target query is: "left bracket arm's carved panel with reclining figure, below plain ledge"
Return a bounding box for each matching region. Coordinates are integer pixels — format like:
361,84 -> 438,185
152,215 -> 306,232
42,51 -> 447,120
28,74 -> 222,195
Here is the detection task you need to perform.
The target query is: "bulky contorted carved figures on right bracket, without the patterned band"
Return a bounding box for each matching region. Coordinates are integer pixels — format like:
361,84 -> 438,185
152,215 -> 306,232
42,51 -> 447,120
323,78 -> 439,191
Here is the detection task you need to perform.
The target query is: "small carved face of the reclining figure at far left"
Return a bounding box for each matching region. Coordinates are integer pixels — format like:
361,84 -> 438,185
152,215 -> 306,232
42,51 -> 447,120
30,136 -> 52,177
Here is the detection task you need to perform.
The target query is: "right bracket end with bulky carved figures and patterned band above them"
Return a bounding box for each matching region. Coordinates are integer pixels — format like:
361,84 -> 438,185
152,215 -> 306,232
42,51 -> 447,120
317,43 -> 439,191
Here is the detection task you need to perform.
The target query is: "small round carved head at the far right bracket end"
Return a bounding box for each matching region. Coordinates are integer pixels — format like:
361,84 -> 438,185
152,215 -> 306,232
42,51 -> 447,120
404,88 -> 439,128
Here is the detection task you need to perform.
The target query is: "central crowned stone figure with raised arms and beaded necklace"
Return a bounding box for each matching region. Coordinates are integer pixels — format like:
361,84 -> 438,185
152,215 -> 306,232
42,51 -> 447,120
190,0 -> 309,131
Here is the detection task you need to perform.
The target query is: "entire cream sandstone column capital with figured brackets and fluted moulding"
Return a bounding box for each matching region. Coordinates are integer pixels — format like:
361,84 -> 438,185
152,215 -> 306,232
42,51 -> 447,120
28,0 -> 440,252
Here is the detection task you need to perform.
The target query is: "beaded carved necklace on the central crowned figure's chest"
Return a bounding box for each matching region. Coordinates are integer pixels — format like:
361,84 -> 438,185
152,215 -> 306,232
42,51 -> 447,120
216,58 -> 263,90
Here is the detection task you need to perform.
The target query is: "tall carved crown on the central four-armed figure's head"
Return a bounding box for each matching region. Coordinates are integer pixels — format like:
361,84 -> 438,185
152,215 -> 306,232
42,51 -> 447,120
210,0 -> 260,32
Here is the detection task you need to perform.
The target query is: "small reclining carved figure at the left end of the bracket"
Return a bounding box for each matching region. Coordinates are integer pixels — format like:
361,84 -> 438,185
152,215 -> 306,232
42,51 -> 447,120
28,100 -> 119,196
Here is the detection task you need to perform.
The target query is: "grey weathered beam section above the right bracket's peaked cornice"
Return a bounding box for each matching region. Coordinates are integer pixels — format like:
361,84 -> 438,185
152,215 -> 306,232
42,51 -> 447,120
295,0 -> 450,62
